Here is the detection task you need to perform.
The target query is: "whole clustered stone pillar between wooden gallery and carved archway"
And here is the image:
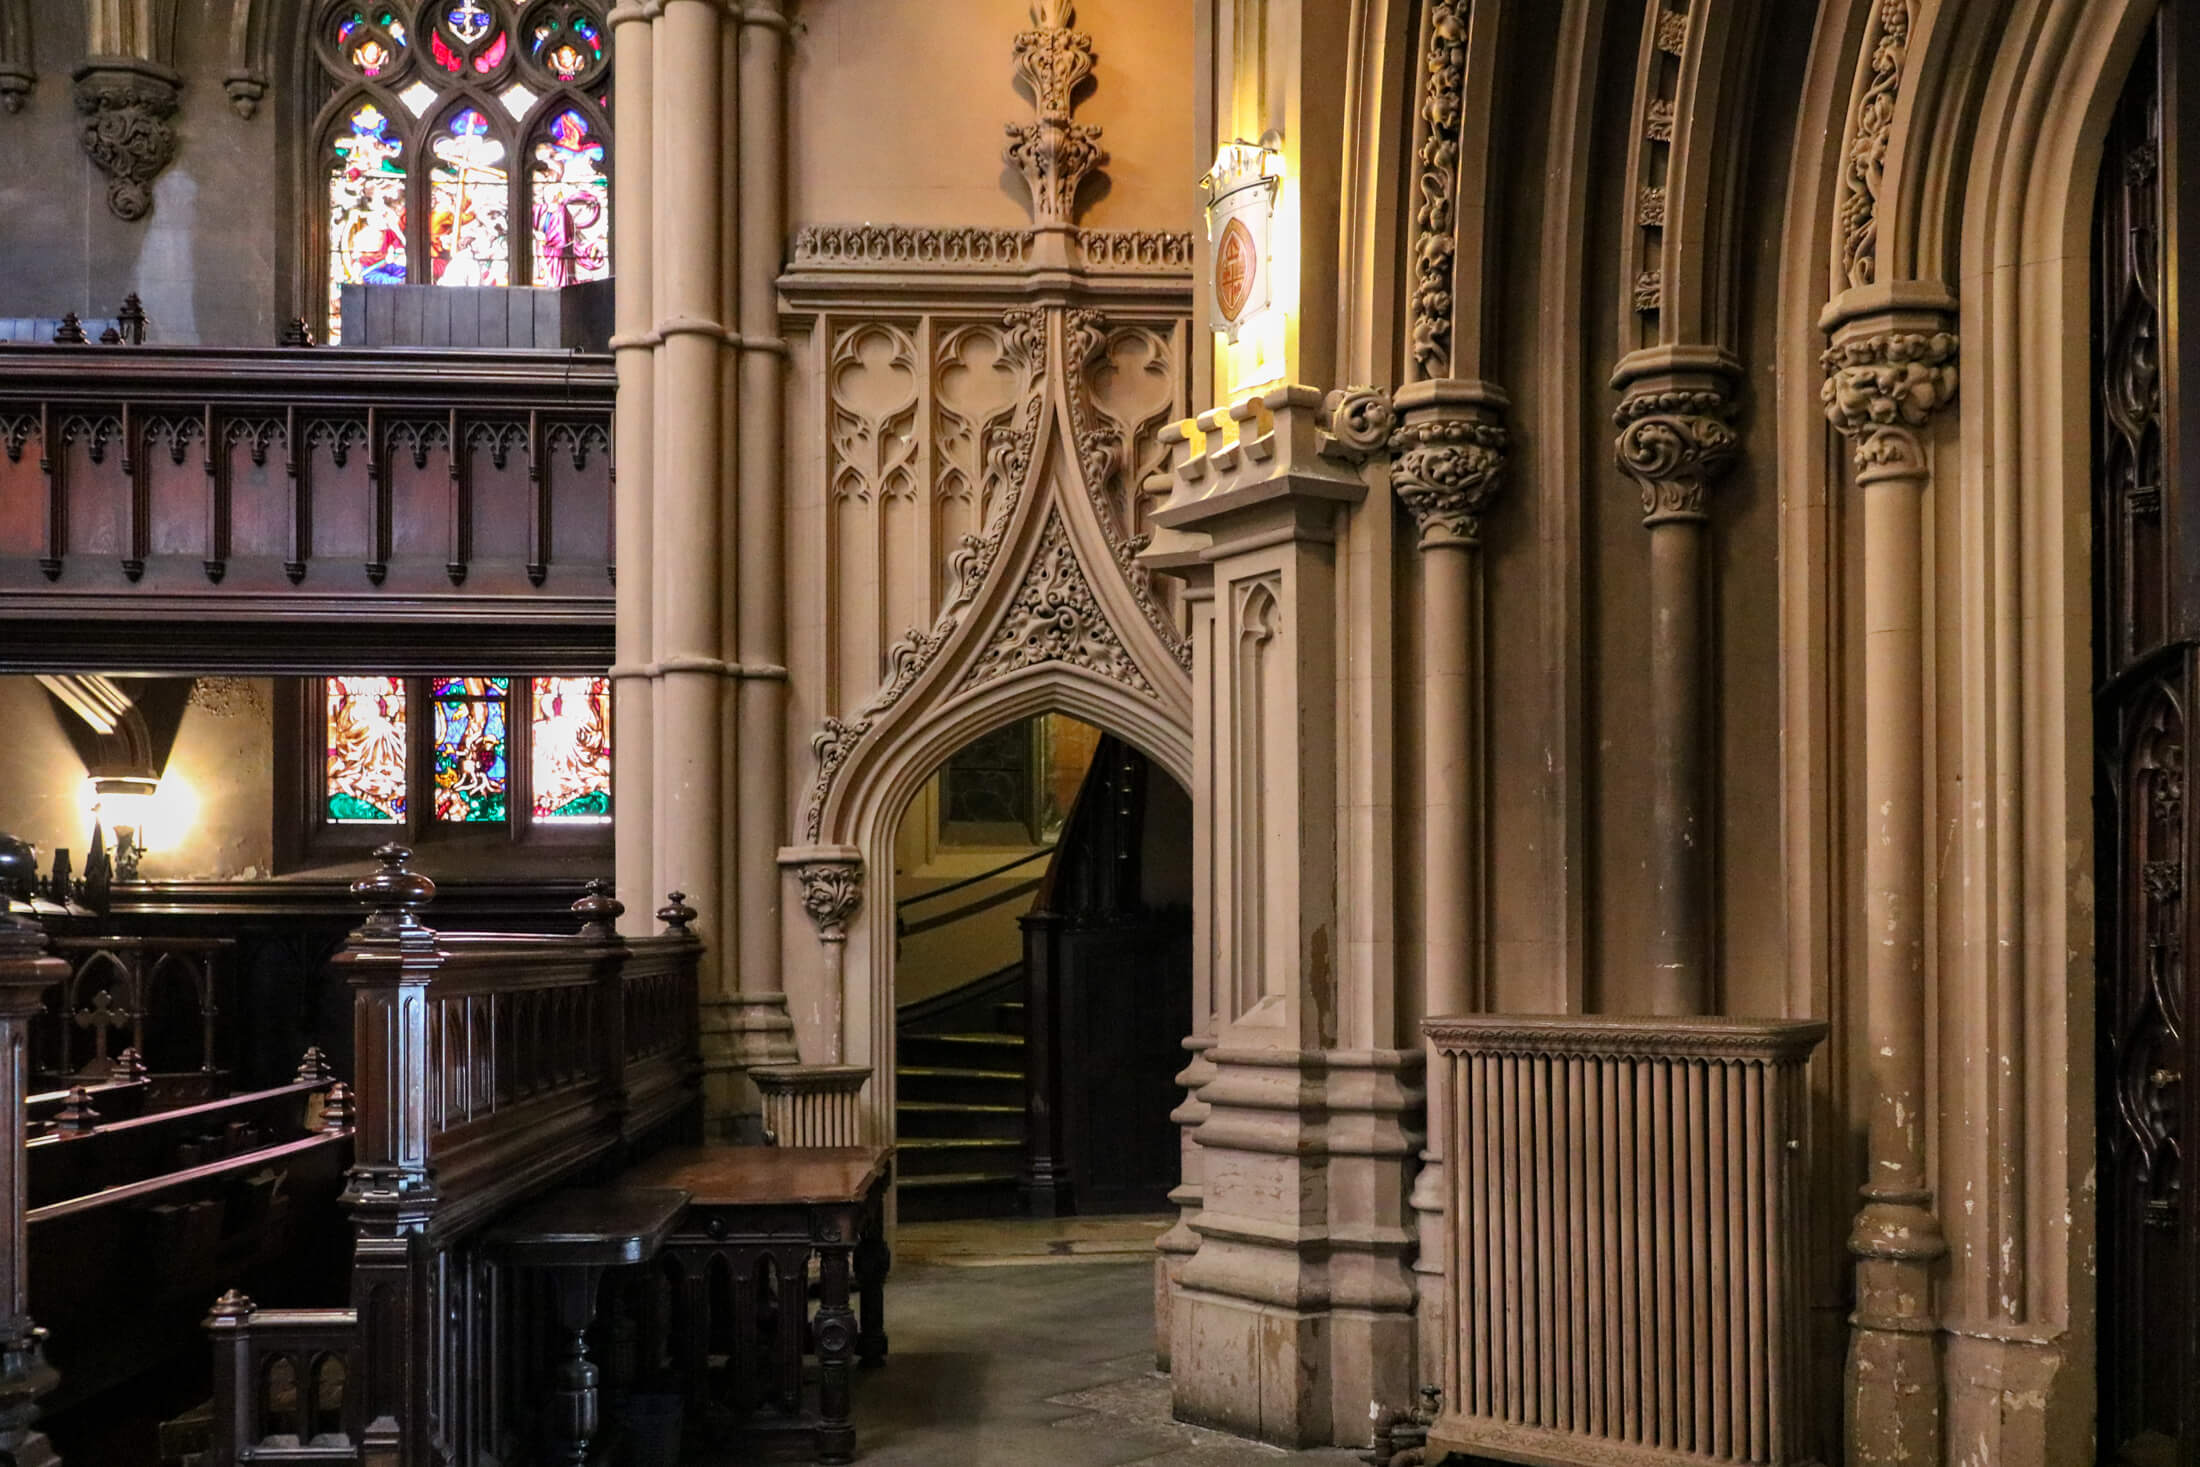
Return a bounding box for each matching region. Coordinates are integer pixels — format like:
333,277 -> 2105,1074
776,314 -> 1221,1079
612,0 -> 796,1133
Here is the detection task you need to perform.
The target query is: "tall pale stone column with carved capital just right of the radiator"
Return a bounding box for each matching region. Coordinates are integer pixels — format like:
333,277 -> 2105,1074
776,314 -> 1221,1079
1824,292 -> 1956,1467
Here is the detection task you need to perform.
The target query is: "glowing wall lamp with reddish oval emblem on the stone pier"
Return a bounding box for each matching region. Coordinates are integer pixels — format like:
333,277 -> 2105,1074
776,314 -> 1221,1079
1199,132 -> 1283,394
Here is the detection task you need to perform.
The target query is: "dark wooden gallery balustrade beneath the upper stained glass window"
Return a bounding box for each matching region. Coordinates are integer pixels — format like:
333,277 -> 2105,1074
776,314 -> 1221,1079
0,343 -> 614,671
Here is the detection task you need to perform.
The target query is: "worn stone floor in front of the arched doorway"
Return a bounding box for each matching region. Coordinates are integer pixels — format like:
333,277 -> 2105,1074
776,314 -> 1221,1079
856,1218 -> 1357,1467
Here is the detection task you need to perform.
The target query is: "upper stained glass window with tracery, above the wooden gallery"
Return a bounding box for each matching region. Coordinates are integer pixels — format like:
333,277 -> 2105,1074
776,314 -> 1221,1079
317,0 -> 612,343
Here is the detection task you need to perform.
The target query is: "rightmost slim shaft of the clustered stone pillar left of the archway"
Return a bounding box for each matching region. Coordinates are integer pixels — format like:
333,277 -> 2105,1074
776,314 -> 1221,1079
728,0 -> 801,1067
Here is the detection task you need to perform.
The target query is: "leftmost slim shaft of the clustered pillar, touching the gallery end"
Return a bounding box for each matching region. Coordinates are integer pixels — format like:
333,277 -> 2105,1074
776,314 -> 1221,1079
609,0 -> 662,935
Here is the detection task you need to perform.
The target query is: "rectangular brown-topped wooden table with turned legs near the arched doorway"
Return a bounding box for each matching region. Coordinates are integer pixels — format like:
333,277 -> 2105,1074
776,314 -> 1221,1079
627,1146 -> 891,1463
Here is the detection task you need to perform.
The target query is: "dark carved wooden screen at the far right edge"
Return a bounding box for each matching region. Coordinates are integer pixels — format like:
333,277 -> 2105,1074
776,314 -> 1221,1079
2092,18 -> 2200,1467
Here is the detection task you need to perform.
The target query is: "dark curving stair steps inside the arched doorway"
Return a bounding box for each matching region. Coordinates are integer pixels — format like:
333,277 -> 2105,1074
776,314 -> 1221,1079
893,994 -> 1025,1221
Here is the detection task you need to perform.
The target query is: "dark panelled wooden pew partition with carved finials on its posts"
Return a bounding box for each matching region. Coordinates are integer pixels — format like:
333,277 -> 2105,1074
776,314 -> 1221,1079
207,847 -> 702,1467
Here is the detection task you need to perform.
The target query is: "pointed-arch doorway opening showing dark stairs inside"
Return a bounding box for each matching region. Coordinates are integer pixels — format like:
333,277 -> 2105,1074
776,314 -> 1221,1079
893,713 -> 1192,1221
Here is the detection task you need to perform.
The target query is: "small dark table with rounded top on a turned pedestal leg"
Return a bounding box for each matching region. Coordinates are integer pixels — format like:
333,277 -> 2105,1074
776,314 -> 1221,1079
488,1188 -> 689,1467
